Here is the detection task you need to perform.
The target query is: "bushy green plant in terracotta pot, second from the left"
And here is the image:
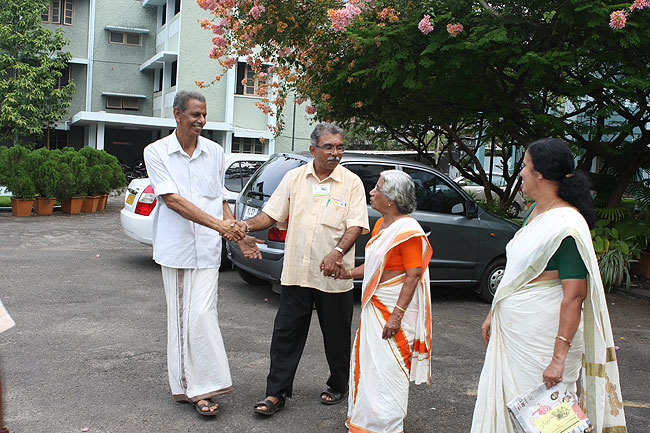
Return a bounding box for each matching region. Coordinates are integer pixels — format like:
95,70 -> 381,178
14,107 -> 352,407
28,148 -> 59,215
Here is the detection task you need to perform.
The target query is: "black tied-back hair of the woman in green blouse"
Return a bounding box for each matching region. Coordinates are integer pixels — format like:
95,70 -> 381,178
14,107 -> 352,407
528,138 -> 596,228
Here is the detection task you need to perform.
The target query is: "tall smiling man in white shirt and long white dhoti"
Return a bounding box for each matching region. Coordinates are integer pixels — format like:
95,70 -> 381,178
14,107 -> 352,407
144,91 -> 245,416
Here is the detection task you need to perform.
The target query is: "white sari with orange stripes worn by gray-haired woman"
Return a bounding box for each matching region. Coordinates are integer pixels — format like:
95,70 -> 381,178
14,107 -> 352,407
346,217 -> 433,433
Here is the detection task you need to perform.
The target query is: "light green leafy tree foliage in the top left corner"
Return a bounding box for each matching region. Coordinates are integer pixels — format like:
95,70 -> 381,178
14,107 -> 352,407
0,0 -> 74,144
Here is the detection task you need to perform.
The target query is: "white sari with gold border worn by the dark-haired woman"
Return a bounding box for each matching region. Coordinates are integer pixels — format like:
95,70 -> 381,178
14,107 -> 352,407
471,207 -> 627,433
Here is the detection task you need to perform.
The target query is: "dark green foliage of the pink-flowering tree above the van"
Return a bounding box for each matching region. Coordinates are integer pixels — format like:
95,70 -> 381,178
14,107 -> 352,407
210,0 -> 650,208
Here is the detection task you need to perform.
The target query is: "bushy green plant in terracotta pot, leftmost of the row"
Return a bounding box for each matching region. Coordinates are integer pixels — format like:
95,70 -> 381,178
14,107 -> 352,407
3,146 -> 36,216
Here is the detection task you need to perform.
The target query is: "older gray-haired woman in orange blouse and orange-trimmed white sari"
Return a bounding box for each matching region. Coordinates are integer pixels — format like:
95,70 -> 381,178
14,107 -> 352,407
339,170 -> 433,433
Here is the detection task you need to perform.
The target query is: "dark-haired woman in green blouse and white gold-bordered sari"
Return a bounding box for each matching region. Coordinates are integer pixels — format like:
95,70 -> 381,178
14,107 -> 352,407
471,138 -> 627,433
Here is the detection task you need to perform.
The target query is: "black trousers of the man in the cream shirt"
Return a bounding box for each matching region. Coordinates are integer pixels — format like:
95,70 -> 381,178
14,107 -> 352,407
266,286 -> 354,397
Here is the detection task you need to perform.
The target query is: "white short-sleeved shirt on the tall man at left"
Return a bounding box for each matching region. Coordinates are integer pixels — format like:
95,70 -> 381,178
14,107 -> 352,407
144,131 -> 225,269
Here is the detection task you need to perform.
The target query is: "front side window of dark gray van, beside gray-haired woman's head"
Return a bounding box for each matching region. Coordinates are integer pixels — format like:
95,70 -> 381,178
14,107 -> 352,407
404,167 -> 465,214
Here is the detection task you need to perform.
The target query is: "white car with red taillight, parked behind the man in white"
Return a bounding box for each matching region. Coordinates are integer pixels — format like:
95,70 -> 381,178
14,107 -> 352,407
120,153 -> 269,246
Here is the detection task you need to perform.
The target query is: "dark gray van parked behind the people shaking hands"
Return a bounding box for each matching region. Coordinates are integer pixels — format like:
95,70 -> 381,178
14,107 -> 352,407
227,151 -> 518,302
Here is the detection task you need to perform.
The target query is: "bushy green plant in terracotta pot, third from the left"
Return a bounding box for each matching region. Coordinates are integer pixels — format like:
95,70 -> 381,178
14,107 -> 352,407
56,147 -> 88,214
